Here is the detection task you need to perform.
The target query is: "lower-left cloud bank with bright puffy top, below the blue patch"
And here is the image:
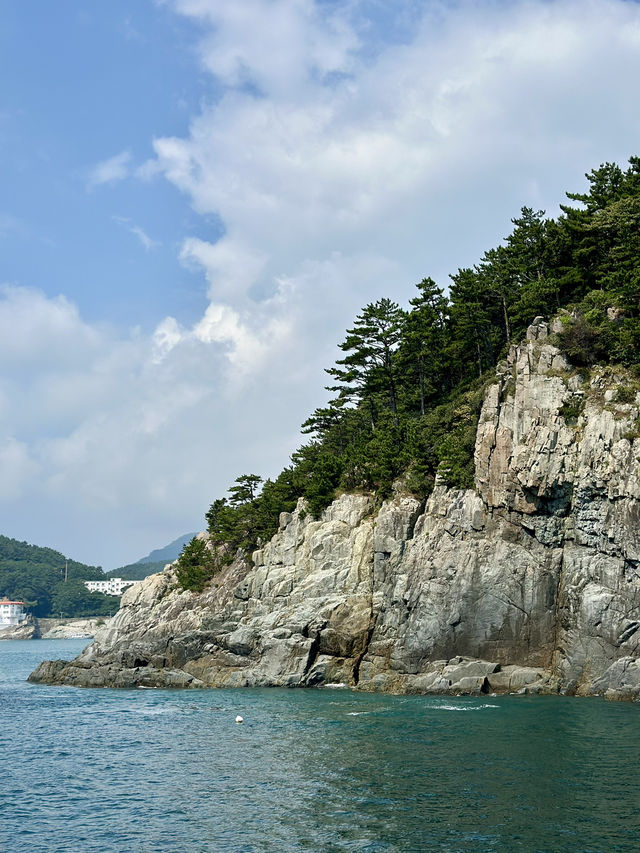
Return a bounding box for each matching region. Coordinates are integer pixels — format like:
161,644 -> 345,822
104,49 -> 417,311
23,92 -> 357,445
0,287 -> 310,567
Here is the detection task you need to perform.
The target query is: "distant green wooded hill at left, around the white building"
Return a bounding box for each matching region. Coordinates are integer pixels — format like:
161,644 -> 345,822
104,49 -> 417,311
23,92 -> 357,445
0,536 -> 118,617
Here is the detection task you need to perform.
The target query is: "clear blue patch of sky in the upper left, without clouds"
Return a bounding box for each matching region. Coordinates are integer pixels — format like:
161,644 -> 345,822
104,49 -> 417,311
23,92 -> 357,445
0,0 -> 217,329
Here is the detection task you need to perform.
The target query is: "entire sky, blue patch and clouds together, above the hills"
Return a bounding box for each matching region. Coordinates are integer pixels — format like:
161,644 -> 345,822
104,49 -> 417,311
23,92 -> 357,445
0,0 -> 640,568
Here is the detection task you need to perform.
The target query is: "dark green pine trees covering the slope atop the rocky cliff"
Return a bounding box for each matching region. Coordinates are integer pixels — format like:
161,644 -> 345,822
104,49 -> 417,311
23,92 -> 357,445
179,157 -> 640,589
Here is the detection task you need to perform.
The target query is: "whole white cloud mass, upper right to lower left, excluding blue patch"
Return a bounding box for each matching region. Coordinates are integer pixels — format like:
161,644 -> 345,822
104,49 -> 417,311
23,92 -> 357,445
10,0 -> 640,565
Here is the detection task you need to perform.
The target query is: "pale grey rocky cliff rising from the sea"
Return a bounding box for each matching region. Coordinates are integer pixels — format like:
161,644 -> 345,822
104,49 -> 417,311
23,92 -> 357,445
31,321 -> 640,698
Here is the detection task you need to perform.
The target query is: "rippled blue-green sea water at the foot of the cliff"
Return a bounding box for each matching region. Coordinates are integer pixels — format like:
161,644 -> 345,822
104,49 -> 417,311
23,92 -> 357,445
0,640 -> 640,853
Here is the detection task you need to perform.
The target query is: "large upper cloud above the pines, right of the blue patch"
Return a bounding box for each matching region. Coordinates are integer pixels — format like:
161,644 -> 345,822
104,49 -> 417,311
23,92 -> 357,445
154,0 -> 640,330
